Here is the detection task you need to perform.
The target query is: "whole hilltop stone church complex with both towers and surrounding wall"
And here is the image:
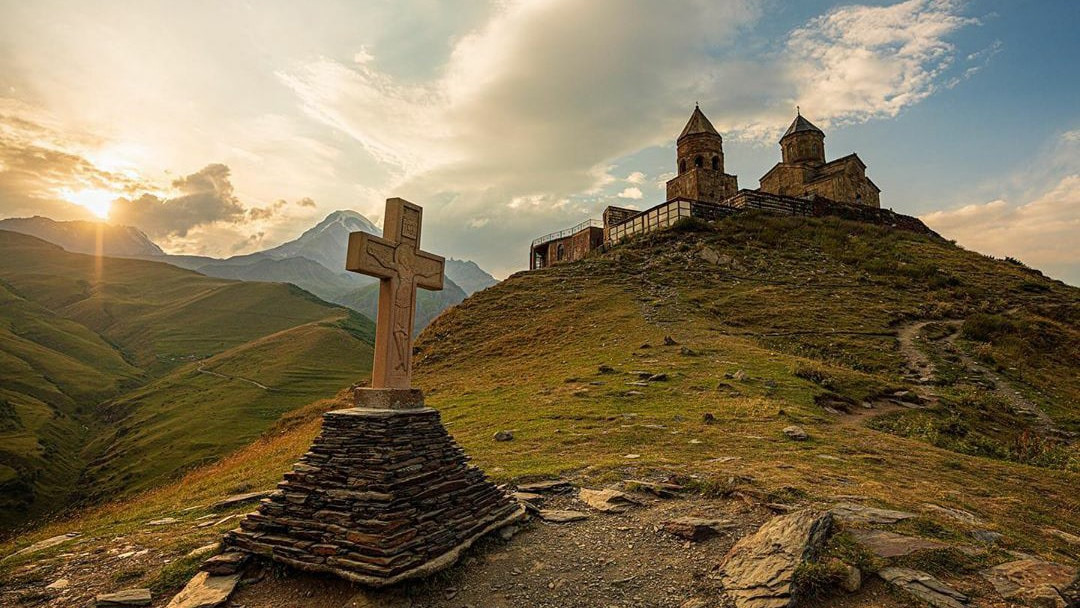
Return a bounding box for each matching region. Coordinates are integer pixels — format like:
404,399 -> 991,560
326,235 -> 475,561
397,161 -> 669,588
529,106 -> 911,269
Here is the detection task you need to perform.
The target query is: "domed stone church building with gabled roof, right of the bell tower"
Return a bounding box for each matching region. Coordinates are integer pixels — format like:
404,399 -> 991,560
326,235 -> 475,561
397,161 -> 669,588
760,114 -> 881,208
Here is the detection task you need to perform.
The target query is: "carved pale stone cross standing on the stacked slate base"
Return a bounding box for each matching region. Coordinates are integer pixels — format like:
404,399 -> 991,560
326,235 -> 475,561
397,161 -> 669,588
345,199 -> 444,389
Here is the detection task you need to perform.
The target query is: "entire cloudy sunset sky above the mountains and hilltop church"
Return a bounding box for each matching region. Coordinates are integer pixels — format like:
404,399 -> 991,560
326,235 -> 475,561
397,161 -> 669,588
0,0 -> 1080,285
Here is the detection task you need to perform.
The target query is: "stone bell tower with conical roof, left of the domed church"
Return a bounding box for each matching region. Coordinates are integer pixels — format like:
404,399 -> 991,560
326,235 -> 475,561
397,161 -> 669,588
667,104 -> 739,203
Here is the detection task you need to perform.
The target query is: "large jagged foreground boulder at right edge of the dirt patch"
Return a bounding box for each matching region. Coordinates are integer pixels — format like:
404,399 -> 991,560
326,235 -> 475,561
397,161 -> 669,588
718,511 -> 833,608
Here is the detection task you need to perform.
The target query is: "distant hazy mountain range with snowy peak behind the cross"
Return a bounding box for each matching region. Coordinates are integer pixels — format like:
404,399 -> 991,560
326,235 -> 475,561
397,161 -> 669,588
0,210 -> 497,333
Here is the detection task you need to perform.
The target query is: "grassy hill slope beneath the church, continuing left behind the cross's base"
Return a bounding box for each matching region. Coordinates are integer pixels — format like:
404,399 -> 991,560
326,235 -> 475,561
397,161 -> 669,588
0,216 -> 1080,590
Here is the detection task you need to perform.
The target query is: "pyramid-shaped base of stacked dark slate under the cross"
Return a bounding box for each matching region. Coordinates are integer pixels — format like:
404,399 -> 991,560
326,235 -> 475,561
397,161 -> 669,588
225,389 -> 525,586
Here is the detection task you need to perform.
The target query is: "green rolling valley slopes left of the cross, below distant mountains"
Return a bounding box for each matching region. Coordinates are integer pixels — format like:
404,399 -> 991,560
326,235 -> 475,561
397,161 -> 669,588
0,231 -> 373,525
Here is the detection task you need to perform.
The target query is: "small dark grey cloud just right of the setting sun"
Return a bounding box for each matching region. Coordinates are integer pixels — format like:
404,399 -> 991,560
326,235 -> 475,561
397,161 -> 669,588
109,164 -> 246,237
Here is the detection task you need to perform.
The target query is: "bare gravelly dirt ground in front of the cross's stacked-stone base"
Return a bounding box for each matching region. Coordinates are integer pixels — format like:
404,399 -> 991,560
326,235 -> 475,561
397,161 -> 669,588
232,496 -> 772,608
